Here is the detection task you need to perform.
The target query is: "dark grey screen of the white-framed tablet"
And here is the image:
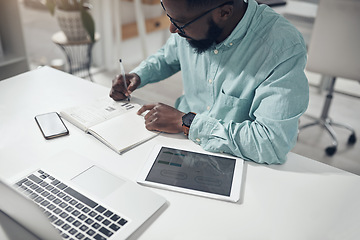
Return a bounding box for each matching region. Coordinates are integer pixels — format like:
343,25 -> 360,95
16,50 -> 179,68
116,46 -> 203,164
145,147 -> 236,196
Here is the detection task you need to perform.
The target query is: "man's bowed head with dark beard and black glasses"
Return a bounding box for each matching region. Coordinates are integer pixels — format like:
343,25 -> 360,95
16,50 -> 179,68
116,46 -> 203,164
161,0 -> 238,53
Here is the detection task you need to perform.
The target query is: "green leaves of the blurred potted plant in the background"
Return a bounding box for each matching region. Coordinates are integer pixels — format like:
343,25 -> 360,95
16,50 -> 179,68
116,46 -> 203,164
45,0 -> 95,42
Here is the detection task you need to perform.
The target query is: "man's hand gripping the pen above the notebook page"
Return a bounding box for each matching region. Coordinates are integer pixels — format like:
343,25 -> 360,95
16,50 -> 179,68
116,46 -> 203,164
109,73 -> 141,101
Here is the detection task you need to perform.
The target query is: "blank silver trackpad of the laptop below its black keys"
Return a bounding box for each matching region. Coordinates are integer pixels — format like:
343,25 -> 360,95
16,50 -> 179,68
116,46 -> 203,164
71,166 -> 125,198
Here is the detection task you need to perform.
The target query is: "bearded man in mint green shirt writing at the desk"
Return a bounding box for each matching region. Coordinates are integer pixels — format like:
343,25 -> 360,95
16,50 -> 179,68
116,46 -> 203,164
110,0 -> 309,164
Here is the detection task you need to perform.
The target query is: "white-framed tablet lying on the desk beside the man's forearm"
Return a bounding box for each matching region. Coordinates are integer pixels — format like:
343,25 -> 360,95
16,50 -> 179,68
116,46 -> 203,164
137,145 -> 244,202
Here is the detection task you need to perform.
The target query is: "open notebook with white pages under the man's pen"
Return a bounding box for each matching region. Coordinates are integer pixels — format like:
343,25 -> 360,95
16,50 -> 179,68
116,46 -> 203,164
60,97 -> 159,154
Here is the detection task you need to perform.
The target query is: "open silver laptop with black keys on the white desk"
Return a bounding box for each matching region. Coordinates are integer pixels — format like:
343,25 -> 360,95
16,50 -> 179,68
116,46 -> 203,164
0,152 -> 166,240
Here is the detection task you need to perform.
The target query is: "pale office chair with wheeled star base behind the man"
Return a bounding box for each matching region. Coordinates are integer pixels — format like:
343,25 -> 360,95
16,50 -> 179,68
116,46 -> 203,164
299,0 -> 360,156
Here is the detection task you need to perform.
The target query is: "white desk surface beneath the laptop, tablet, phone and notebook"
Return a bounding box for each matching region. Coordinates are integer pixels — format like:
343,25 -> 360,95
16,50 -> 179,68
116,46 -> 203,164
0,67 -> 360,240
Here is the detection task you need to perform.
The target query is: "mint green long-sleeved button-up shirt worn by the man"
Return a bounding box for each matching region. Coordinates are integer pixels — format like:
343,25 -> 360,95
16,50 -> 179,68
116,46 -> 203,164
132,0 -> 309,164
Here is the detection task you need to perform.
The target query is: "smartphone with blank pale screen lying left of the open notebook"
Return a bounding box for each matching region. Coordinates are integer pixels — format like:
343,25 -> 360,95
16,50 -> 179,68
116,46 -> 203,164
35,112 -> 69,139
